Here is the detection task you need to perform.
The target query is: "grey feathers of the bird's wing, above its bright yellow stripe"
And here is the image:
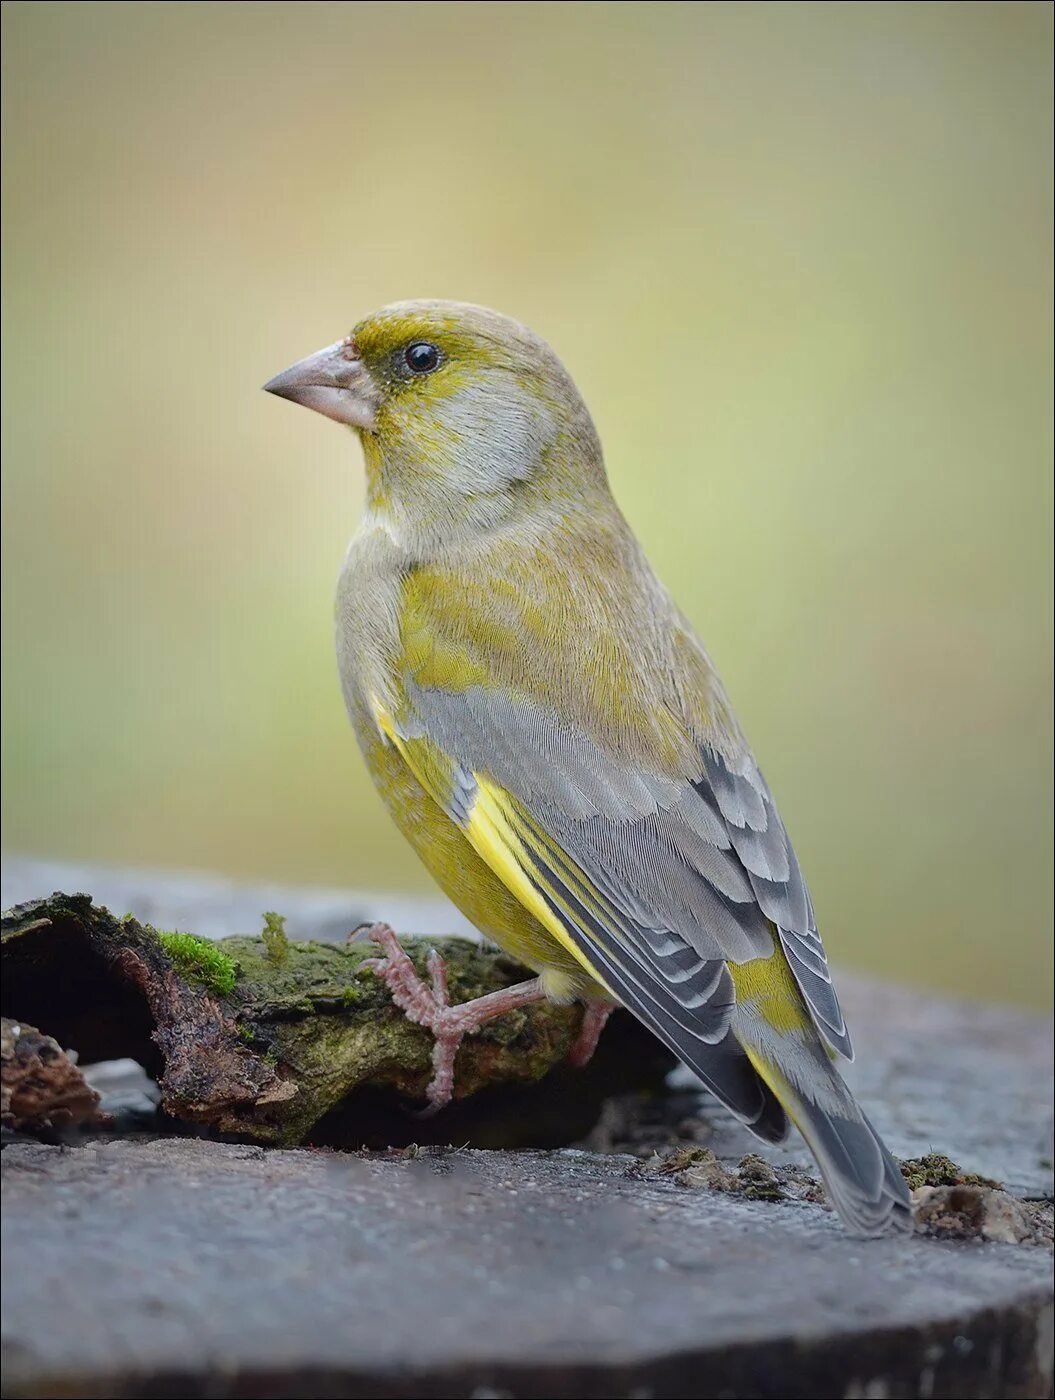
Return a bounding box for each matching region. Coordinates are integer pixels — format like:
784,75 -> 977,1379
404,682 -> 851,1056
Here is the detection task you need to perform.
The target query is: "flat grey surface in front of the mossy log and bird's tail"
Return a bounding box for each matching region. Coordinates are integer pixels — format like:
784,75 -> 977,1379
3,1140 -> 1051,1397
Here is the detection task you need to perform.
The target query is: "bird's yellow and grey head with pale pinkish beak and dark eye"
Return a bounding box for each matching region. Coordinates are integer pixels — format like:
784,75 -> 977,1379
264,301 -> 603,537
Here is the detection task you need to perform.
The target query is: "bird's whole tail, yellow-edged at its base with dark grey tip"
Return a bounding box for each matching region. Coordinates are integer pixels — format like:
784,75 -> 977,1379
747,1046 -> 912,1236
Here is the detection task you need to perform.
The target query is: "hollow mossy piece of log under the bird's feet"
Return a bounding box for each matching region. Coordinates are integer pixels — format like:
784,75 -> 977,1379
3,893 -> 672,1145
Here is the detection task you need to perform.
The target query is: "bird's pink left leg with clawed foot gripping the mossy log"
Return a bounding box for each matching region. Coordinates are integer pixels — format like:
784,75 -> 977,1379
361,924 -> 545,1113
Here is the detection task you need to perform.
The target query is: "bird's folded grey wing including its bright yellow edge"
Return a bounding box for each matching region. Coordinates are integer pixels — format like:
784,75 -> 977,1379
379,682 -> 849,1135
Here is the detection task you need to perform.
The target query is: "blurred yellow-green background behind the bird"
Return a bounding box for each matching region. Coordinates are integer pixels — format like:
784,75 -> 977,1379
3,3 -> 1051,1004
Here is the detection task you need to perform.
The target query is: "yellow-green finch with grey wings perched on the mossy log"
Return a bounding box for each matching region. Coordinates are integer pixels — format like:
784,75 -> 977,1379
264,301 -> 911,1235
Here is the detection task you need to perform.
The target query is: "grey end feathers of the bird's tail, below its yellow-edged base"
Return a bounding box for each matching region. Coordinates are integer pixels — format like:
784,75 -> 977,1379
785,1075 -> 912,1236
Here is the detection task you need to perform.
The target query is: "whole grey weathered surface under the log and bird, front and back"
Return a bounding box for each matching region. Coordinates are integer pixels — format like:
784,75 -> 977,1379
3,865 -> 1052,1400
